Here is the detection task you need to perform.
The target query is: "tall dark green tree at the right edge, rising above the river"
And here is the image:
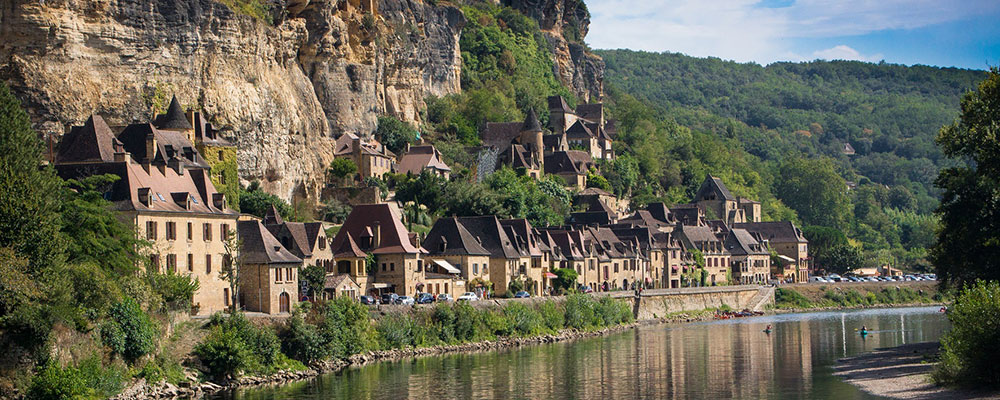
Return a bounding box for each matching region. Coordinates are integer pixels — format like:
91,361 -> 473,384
930,67 -> 1000,285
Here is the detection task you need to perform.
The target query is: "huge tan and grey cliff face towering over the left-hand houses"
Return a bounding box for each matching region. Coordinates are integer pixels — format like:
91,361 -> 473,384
0,0 -> 465,201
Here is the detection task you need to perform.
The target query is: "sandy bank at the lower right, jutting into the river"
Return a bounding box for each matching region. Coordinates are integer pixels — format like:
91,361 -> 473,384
834,342 -> 1000,400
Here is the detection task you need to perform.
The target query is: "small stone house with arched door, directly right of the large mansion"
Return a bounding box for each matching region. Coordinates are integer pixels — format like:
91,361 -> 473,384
237,220 -> 302,315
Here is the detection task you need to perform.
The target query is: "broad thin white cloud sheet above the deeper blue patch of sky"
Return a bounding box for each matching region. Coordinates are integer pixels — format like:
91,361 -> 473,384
587,0 -> 1000,63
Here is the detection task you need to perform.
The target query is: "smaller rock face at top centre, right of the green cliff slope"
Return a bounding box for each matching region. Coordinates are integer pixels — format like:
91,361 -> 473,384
500,0 -> 604,102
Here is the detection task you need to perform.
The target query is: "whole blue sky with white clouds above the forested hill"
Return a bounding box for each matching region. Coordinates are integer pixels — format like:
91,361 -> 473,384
586,0 -> 1000,69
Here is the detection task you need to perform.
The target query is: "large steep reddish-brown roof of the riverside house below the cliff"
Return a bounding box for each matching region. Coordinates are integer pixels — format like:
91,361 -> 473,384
333,203 -> 420,254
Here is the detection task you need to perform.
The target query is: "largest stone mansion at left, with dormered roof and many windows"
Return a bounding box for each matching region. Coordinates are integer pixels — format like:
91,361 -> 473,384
54,113 -> 238,315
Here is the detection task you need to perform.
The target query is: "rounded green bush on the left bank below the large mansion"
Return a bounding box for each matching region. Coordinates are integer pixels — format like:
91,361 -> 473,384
101,297 -> 157,363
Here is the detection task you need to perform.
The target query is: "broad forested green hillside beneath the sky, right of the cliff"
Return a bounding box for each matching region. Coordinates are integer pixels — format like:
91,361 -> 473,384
597,50 -> 986,265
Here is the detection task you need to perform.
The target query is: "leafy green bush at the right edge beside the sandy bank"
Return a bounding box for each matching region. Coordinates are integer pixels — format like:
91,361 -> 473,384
932,281 -> 1000,387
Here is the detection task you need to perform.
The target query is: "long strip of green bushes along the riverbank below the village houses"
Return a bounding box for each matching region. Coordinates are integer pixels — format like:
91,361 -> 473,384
194,294 -> 634,381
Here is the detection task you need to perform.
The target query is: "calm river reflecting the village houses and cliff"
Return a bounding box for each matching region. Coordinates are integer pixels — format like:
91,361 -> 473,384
218,307 -> 949,400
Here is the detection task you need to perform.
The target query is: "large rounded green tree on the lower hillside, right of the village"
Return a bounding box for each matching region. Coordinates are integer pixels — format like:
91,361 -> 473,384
777,158 -> 851,229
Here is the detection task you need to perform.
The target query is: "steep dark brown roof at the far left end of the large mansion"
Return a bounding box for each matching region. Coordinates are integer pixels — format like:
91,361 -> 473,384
56,115 -> 123,163
